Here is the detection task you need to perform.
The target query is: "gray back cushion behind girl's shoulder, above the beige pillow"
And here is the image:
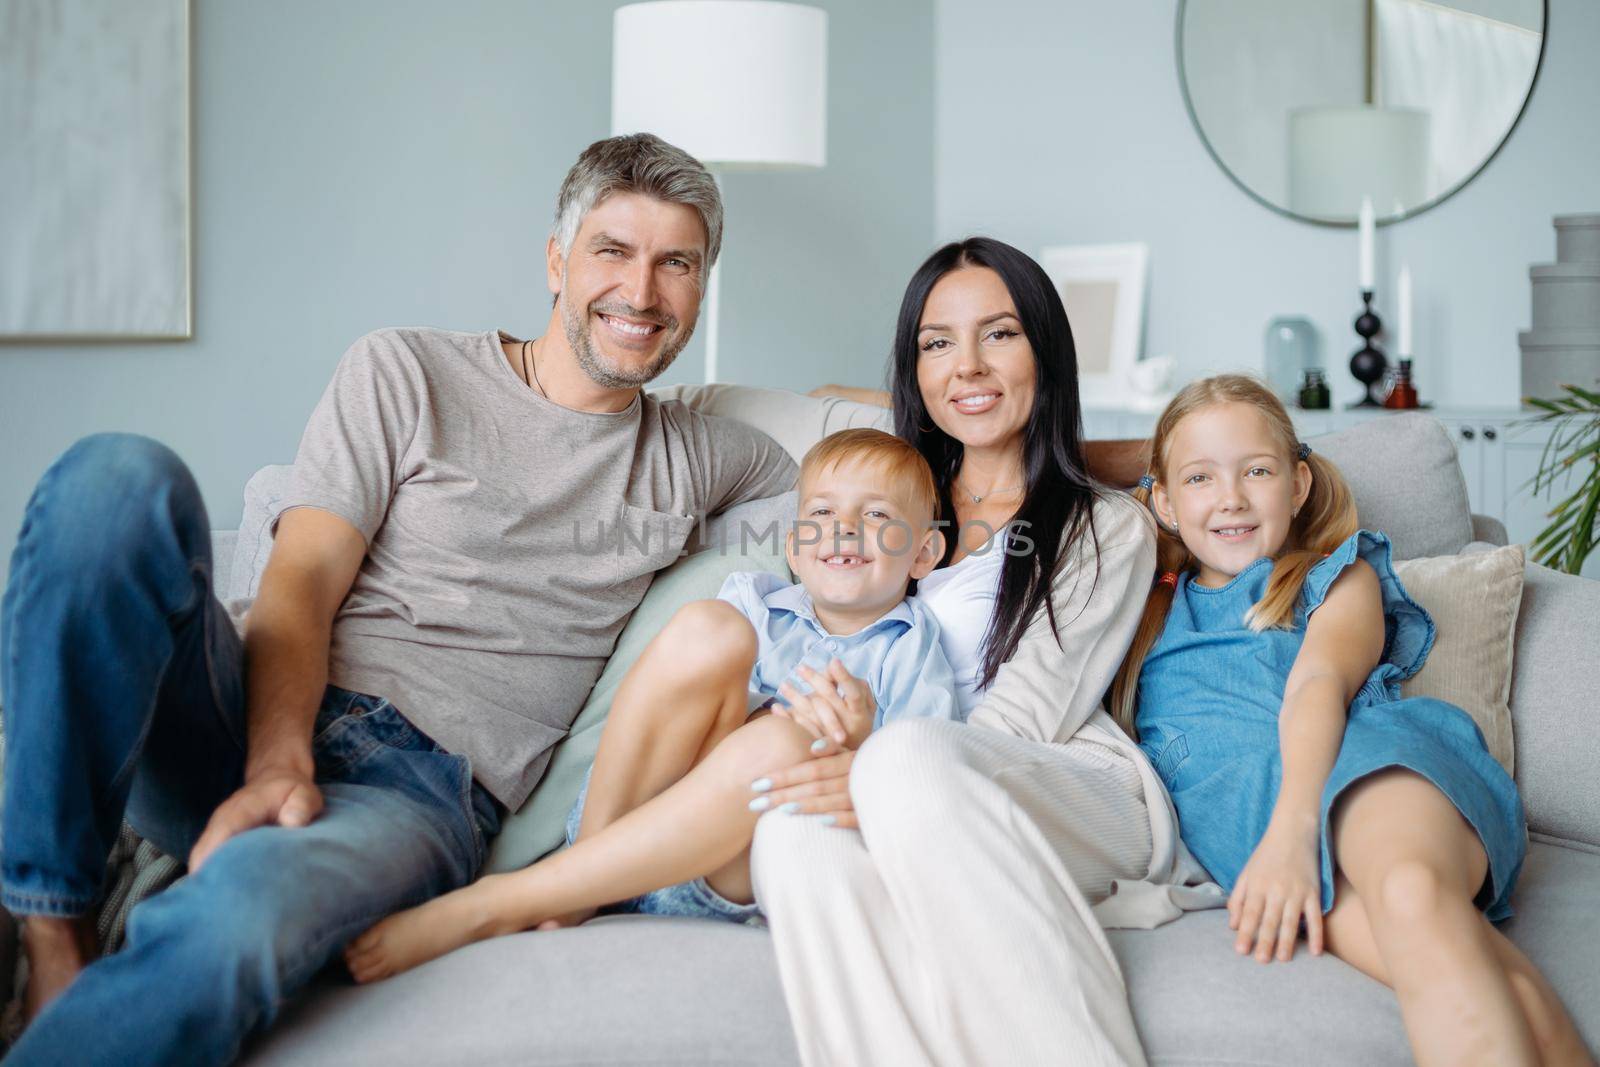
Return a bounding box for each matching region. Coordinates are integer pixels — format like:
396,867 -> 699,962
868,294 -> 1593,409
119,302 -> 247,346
1310,413 -> 1472,560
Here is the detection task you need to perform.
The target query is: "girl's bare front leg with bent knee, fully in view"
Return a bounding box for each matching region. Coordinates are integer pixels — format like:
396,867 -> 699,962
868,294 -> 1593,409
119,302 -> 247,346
1330,769 -> 1561,1065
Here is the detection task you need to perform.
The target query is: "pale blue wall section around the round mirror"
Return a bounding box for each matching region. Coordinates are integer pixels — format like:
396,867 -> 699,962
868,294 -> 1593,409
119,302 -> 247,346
934,0 -> 1600,406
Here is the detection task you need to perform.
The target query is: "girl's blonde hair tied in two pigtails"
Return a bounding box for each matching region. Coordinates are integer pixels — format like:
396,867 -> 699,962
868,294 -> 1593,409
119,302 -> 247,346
1110,374 -> 1357,737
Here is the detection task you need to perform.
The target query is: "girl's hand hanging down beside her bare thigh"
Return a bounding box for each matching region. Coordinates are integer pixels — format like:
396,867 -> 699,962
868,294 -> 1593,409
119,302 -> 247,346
1227,817 -> 1322,963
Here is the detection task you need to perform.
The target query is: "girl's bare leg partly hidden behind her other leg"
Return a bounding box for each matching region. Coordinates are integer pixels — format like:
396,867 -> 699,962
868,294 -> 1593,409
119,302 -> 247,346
1323,872 -> 1594,1067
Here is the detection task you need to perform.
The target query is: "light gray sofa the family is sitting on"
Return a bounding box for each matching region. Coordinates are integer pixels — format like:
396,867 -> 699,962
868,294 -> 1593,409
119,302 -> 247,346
34,404 -> 1600,1067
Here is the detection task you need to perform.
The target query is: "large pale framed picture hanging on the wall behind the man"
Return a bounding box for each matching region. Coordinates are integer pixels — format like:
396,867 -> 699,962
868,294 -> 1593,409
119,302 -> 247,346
0,0 -> 194,341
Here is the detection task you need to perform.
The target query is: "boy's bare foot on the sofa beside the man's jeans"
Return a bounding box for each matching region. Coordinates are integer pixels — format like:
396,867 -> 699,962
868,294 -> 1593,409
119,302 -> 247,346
344,877 -> 524,982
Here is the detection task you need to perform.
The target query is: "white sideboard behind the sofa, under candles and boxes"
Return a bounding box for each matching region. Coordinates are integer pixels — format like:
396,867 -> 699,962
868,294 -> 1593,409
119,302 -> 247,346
1083,406 -> 1600,577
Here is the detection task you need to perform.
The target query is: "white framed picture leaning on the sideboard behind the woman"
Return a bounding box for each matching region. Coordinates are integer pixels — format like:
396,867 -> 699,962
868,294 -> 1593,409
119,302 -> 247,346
1040,245 -> 1150,403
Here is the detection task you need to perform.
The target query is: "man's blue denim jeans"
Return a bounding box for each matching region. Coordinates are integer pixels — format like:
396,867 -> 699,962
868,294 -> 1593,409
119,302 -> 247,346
0,434 -> 499,1067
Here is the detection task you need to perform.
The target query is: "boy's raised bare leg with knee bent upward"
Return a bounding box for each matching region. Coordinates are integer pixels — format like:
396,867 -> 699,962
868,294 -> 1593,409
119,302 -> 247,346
578,600 -> 757,837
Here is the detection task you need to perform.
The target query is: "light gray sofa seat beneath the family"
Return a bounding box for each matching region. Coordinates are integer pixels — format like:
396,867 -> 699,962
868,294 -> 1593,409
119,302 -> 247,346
233,841 -> 1600,1067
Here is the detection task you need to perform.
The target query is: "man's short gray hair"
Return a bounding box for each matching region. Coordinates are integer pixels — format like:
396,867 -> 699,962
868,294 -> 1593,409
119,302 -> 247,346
550,133 -> 722,270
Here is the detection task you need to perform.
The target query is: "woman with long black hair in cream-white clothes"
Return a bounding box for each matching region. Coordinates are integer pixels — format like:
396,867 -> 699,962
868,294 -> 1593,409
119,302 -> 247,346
736,238 -> 1219,1064
